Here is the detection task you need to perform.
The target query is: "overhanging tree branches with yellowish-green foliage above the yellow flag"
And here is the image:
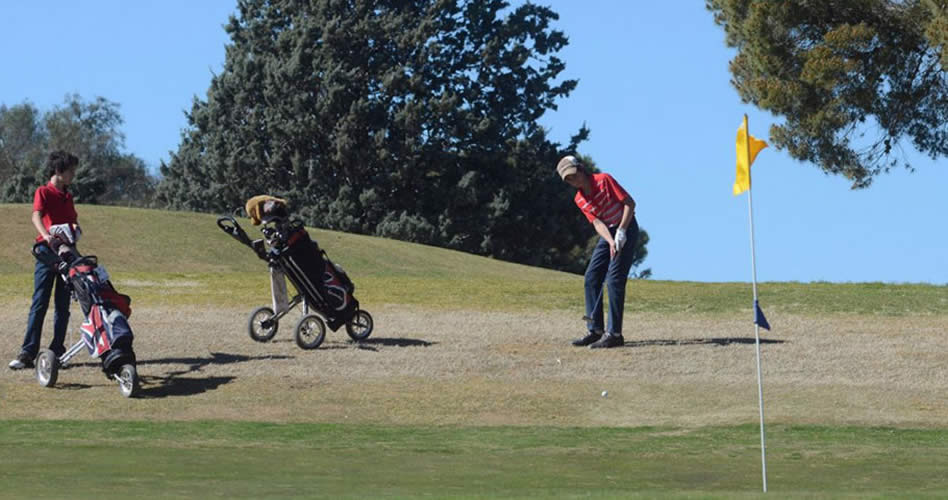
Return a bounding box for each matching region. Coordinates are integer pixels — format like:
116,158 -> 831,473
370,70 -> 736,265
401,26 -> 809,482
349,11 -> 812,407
705,0 -> 948,188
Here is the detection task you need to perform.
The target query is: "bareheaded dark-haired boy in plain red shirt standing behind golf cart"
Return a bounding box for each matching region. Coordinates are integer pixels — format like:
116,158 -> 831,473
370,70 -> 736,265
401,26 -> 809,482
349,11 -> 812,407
9,151 -> 79,370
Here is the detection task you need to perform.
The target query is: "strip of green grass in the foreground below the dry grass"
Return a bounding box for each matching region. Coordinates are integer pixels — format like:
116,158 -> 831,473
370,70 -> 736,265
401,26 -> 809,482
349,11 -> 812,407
0,421 -> 948,499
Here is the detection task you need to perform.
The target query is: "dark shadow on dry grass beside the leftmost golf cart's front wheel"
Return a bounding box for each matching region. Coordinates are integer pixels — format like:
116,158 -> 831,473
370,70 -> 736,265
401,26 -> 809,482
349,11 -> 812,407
137,352 -> 292,398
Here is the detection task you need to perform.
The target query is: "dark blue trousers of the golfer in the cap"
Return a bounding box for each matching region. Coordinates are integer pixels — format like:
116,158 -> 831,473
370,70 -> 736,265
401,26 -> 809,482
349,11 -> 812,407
586,219 -> 639,335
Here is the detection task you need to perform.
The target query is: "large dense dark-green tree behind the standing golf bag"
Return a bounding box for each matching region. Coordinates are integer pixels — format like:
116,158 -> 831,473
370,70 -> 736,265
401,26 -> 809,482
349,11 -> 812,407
159,0 -> 652,271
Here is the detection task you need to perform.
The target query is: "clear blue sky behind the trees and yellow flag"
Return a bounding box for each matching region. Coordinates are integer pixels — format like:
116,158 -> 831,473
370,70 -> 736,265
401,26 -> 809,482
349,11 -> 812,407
0,0 -> 948,285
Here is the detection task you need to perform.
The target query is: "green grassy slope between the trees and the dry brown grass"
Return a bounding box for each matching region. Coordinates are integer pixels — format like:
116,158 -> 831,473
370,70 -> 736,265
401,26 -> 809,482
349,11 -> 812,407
0,204 -> 948,316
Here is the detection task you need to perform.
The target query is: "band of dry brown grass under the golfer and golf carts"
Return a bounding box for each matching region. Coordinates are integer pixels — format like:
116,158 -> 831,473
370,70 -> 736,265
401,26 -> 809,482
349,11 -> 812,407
0,301 -> 948,426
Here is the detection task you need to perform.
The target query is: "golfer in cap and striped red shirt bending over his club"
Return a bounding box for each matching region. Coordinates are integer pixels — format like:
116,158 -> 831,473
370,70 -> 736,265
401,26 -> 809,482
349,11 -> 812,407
556,156 -> 639,349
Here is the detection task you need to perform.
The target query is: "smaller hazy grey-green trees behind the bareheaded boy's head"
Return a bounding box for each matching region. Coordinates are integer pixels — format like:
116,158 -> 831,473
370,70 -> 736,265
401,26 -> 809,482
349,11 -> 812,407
0,95 -> 157,206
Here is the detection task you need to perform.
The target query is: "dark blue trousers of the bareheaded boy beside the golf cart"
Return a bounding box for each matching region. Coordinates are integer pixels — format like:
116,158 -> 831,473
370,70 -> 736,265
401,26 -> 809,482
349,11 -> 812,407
20,246 -> 69,358
